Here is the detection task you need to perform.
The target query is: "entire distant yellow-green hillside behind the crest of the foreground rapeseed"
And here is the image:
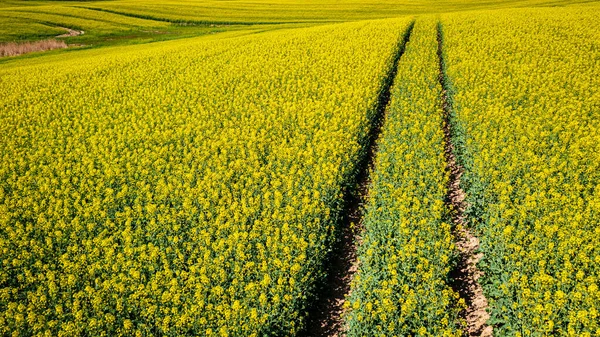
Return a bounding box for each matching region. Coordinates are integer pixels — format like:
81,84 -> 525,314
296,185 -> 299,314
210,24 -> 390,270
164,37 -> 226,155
0,0 -> 589,46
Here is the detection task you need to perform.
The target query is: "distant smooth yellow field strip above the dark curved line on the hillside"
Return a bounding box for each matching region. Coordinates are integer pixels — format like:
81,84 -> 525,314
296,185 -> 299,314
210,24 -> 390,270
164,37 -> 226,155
64,0 -> 586,24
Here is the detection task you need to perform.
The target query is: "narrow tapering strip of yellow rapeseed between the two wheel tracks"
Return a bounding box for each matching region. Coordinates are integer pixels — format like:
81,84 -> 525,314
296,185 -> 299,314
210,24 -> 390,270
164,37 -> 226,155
347,17 -> 461,337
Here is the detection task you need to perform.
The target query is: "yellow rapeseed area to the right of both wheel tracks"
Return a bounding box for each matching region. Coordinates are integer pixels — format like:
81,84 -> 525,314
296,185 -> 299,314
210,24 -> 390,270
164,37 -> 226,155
443,7 -> 600,336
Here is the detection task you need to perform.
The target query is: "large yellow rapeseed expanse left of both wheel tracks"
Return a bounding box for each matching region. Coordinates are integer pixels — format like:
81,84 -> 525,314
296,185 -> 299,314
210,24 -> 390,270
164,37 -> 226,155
0,19 -> 409,337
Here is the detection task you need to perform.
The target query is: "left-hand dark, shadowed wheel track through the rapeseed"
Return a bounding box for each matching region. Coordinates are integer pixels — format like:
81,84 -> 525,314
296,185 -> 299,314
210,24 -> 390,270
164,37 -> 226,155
305,21 -> 414,337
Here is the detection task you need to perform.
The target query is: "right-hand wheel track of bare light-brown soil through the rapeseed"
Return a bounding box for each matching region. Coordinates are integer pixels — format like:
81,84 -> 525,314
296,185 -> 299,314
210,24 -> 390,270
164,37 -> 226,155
438,25 -> 493,337
